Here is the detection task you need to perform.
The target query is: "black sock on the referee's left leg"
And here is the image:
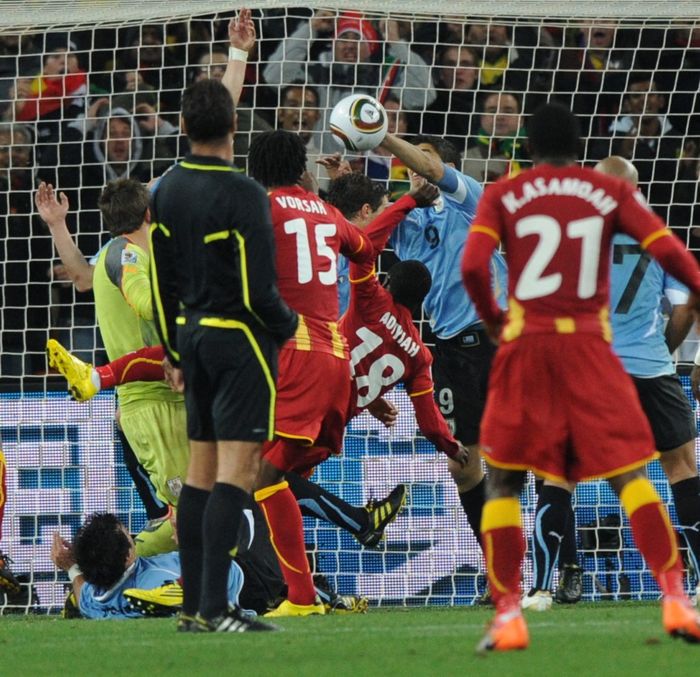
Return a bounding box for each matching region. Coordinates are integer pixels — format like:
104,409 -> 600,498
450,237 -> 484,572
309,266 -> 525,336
177,484 -> 210,616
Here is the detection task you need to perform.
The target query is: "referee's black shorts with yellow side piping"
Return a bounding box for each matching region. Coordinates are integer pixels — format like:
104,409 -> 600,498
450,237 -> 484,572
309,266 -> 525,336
177,318 -> 277,442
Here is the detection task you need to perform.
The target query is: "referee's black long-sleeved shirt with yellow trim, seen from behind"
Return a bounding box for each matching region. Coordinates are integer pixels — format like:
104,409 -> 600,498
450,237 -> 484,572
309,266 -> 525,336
151,155 -> 297,363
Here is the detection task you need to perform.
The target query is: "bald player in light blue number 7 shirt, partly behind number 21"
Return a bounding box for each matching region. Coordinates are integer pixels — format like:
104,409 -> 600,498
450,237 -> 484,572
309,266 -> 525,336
522,156 -> 700,611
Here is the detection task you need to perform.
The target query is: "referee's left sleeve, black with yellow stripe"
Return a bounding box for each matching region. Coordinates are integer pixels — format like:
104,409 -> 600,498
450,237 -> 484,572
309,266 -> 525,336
150,221 -> 180,366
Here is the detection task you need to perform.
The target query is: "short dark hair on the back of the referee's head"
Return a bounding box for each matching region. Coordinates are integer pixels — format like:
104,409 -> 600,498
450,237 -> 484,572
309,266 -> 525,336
181,79 -> 236,143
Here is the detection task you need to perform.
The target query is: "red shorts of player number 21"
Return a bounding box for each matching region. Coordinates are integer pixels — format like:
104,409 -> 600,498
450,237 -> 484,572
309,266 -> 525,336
480,334 -> 656,482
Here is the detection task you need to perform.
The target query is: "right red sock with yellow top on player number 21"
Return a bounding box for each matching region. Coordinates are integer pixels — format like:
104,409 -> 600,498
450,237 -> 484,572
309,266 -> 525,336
620,477 -> 685,596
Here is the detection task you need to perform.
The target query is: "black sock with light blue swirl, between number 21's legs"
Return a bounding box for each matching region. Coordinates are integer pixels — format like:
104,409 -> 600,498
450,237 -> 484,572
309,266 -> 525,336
532,485 -> 571,590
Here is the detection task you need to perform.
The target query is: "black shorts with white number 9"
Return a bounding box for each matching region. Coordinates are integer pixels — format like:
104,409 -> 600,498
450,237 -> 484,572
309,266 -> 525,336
433,329 -> 496,445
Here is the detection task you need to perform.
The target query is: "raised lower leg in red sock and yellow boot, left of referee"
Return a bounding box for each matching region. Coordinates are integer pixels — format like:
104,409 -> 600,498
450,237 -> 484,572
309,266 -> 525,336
46,339 -> 165,402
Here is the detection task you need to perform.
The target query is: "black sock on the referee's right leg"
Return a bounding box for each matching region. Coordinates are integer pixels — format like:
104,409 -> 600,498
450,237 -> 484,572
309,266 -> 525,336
199,482 -> 250,619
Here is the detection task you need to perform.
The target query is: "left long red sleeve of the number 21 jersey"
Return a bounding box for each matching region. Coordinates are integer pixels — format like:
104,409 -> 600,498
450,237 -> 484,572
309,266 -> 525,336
462,184 -> 503,322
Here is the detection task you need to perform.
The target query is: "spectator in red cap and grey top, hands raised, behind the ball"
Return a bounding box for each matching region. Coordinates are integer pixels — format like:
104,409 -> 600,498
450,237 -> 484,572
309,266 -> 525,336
263,12 -> 435,152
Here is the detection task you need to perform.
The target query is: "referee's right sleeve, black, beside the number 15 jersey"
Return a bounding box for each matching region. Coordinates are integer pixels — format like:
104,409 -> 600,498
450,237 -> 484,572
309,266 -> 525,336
237,189 -> 298,344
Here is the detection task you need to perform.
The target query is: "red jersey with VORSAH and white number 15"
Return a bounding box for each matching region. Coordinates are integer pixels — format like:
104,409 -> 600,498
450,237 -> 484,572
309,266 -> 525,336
269,186 -> 374,359
